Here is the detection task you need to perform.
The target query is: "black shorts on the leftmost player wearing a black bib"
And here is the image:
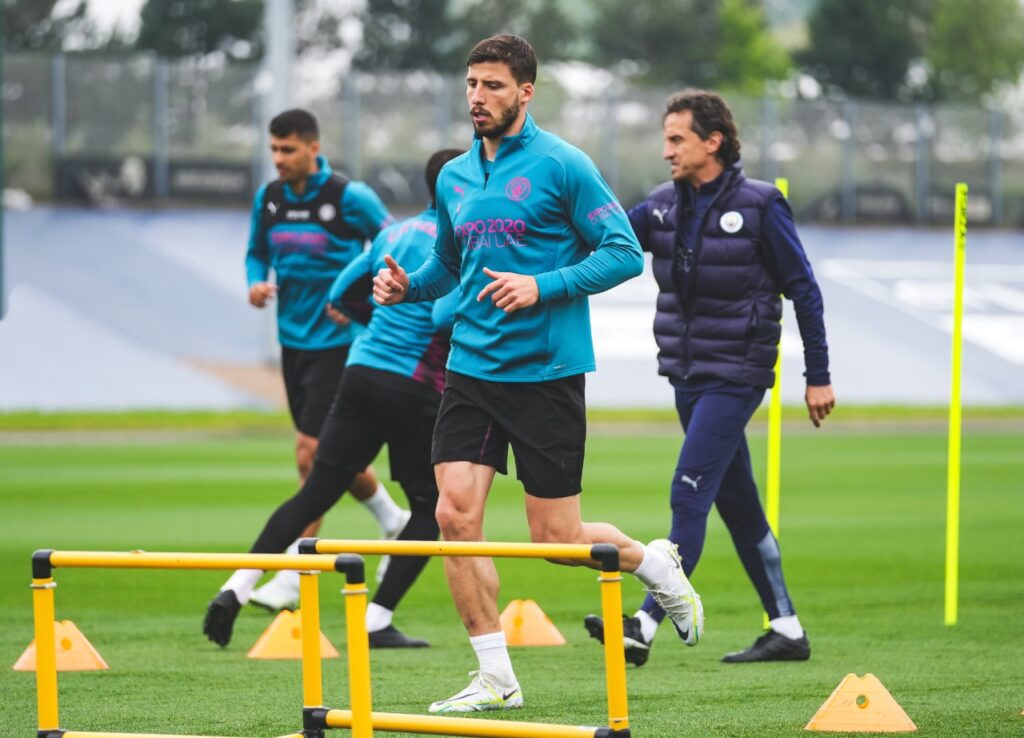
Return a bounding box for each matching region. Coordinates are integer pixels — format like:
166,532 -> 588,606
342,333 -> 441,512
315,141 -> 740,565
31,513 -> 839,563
281,346 -> 348,438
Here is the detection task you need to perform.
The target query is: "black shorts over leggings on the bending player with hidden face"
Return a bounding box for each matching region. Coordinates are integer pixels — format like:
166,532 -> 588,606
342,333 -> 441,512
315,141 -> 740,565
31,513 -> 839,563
316,364 -> 441,492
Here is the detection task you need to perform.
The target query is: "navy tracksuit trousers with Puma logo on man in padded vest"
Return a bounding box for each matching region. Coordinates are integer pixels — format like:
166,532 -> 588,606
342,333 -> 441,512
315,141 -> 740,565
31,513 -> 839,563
643,380 -> 795,622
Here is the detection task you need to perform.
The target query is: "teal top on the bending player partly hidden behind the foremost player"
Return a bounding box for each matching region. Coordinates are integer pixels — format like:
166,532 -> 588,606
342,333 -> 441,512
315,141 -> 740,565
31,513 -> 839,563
328,208 -> 457,392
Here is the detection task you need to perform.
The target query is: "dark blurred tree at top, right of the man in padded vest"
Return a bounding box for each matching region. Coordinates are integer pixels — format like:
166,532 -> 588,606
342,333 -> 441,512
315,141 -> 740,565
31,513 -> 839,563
797,0 -> 929,99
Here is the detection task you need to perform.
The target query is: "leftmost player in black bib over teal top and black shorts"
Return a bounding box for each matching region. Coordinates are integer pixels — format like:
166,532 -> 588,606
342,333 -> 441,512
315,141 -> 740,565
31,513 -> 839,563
245,110 -> 409,610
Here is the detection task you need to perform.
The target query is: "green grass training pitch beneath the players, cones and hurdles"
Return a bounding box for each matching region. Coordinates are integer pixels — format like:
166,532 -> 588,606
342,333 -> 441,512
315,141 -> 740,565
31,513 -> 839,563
0,423 -> 1024,738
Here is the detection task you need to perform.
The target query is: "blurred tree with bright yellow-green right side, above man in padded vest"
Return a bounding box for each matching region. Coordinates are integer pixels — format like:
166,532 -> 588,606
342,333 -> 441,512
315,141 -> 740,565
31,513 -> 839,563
589,0 -> 790,93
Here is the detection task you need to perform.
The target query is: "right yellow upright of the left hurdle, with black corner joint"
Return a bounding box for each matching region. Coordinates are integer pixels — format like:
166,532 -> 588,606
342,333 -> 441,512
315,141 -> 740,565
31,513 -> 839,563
338,557 -> 374,738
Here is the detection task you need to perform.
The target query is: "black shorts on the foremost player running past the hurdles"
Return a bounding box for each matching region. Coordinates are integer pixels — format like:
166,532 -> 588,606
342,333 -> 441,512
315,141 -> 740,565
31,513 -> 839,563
431,372 -> 587,497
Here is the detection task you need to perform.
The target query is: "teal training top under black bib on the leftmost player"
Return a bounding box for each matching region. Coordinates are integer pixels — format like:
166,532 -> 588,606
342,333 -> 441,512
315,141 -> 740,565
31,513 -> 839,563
246,155 -> 393,351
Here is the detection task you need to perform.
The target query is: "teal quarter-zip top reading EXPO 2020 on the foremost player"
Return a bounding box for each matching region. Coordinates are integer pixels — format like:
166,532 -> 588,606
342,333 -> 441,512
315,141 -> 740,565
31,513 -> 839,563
398,115 -> 643,382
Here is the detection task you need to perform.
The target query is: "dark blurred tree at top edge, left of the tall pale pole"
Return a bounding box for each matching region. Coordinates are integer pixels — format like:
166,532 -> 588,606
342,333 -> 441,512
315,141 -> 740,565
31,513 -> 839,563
135,0 -> 263,59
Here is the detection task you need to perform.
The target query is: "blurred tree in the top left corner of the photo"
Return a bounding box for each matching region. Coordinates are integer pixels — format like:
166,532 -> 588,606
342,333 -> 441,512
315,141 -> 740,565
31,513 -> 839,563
3,0 -> 97,52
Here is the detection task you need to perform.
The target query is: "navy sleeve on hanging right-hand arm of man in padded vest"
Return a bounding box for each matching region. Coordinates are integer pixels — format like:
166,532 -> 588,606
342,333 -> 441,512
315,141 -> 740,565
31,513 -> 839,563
761,194 -> 831,387
